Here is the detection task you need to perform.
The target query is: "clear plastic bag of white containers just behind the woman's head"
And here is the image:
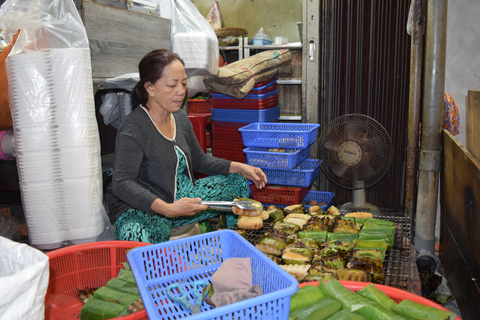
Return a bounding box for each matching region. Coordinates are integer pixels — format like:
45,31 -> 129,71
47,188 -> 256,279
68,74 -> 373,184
170,0 -> 219,97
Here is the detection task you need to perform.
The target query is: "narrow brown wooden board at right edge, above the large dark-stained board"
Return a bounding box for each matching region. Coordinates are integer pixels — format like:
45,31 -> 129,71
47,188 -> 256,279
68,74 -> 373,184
466,90 -> 480,159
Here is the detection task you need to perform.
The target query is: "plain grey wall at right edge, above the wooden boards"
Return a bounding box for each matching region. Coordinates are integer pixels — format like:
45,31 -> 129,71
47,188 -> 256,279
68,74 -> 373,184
445,0 -> 480,146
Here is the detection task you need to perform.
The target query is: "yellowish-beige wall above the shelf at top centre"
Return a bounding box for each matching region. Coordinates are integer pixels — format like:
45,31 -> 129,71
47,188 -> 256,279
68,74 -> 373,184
191,0 -> 303,42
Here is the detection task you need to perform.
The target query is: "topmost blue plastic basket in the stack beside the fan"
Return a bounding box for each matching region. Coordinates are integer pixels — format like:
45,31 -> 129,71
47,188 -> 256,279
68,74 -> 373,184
238,122 -> 320,148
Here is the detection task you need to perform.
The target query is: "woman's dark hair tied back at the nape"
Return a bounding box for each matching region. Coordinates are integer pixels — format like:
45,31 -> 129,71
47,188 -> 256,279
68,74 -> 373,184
131,49 -> 185,109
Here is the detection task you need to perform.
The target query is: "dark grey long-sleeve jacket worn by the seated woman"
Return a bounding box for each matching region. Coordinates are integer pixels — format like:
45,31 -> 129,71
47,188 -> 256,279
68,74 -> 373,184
109,107 -> 231,218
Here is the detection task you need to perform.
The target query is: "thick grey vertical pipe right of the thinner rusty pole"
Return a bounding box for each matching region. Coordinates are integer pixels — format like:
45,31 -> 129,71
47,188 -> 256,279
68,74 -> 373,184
414,0 -> 448,254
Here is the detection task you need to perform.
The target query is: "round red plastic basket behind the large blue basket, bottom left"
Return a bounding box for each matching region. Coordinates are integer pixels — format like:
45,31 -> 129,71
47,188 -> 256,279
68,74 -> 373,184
45,241 -> 149,320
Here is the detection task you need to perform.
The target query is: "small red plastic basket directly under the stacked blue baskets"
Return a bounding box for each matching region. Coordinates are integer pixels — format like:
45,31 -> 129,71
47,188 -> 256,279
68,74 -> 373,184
250,184 -> 312,205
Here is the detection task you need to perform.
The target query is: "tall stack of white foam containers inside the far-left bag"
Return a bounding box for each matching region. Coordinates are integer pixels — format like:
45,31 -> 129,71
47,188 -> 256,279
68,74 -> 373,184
6,48 -> 111,249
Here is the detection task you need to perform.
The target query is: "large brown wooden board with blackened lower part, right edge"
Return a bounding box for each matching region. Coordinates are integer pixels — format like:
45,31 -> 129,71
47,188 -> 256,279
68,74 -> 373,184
439,130 -> 480,319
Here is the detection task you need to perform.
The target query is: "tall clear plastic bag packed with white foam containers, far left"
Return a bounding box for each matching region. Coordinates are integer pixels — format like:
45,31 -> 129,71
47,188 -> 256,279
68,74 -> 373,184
0,0 -> 115,250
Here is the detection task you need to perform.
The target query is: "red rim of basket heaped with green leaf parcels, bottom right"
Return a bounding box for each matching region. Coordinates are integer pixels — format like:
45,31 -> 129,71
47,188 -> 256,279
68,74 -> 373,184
298,280 -> 461,320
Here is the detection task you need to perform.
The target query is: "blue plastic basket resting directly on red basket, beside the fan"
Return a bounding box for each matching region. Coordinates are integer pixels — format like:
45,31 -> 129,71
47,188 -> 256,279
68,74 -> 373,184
260,156 -> 320,187
